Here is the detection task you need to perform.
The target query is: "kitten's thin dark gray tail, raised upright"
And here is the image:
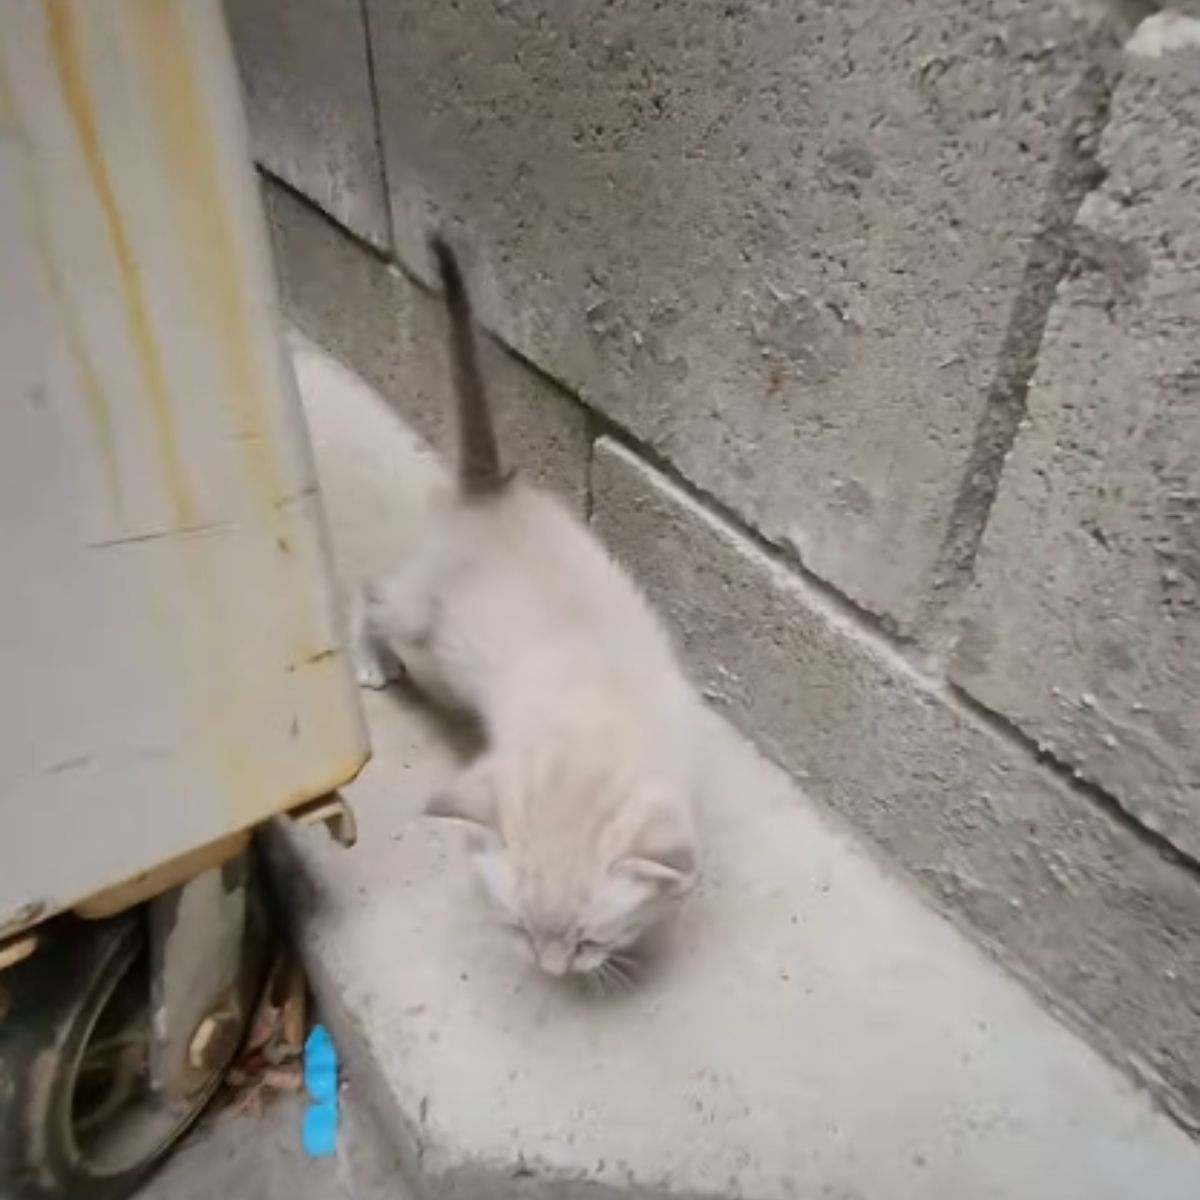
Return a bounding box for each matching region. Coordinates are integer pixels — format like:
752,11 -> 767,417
430,234 -> 508,498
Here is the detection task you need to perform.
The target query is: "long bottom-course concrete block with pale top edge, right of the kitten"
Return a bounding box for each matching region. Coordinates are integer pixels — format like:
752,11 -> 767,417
593,442 -> 1200,1126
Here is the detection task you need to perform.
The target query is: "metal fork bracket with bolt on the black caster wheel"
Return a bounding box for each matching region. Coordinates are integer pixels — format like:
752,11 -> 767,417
149,854 -> 250,1099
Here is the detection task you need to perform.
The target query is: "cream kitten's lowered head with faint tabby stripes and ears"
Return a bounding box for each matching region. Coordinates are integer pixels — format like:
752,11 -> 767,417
426,755 -> 697,976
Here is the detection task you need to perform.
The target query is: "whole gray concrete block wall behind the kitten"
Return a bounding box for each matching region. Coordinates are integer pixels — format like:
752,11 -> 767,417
228,0 -> 1200,1128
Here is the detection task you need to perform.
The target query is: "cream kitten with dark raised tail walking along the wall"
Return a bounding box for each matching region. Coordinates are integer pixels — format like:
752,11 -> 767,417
359,240 -> 697,978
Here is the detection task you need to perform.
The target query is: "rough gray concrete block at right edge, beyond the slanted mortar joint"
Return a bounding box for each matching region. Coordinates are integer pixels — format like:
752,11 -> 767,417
954,35 -> 1200,859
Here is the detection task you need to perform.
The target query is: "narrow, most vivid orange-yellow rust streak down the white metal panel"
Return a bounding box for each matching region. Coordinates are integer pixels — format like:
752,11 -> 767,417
46,0 -> 196,524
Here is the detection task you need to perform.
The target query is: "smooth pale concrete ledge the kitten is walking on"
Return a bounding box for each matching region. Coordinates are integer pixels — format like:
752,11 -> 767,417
267,340 -> 1200,1200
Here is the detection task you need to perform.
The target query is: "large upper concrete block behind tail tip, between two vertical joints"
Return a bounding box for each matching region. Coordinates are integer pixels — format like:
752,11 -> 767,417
370,0 -> 1103,628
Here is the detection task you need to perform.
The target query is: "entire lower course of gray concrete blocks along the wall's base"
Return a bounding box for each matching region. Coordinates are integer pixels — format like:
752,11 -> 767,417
269,187 -> 1200,1127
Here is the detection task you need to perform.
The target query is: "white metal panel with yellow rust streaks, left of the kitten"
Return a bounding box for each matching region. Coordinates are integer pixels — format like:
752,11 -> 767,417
0,0 -> 367,932
